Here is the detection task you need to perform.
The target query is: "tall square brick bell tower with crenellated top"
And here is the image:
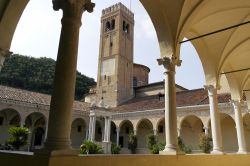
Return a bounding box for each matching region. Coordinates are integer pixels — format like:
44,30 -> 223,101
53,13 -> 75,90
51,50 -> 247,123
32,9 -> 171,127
97,3 -> 134,107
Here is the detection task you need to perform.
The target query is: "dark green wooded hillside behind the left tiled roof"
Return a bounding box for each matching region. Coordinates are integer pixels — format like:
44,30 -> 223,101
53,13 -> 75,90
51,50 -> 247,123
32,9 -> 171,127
0,54 -> 95,100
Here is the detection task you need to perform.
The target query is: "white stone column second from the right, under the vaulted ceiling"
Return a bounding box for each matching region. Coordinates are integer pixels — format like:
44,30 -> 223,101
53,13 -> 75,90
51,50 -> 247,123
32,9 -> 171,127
204,85 -> 223,154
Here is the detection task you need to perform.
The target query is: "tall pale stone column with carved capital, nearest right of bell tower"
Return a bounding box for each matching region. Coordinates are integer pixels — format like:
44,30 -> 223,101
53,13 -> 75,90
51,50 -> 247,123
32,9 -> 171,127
158,57 -> 180,155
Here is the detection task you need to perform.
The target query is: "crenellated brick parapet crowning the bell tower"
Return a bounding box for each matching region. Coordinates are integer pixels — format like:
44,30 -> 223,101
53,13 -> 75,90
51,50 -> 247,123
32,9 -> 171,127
102,2 -> 134,17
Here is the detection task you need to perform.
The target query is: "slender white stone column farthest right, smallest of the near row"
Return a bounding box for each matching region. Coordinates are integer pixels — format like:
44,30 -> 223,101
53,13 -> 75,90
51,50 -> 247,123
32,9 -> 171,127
231,100 -> 247,154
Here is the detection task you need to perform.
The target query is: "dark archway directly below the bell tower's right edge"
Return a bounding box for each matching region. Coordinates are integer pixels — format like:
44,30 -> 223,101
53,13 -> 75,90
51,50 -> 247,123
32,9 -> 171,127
119,120 -> 134,153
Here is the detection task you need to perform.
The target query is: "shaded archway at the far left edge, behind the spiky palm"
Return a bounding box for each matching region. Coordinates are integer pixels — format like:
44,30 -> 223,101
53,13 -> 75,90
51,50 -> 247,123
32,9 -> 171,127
0,109 -> 21,144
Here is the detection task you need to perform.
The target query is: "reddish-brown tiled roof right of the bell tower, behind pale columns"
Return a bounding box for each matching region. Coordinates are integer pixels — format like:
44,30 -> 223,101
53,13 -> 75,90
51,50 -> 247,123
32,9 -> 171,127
112,89 -> 230,112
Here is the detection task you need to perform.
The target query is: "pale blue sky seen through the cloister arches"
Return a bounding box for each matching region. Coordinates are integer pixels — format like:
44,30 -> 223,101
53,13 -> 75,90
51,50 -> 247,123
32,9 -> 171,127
11,0 -> 205,89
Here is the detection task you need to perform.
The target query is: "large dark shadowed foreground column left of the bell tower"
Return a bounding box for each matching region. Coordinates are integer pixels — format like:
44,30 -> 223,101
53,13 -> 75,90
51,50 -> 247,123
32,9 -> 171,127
37,0 -> 94,155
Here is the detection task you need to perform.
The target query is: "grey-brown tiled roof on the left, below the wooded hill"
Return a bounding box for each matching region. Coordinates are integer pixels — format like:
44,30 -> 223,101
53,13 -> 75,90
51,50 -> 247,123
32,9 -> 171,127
0,85 -> 90,110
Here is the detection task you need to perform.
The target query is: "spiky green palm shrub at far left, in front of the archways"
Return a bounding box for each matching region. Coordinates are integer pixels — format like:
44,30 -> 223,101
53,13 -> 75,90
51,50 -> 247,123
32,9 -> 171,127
7,127 -> 29,150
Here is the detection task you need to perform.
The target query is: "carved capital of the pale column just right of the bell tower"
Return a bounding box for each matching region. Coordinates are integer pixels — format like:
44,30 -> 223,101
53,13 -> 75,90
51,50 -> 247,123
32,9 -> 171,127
157,57 -> 182,72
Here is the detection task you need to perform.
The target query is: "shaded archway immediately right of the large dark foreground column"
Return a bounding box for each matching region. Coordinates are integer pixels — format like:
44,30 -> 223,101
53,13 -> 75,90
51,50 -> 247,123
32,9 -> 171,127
70,118 -> 86,149
